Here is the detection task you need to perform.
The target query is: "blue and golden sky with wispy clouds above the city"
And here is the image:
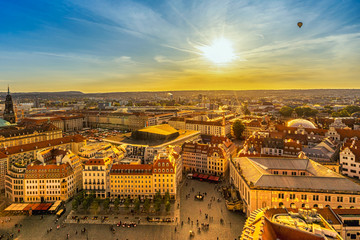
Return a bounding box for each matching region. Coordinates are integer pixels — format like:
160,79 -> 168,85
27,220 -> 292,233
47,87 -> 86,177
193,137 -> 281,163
0,0 -> 360,92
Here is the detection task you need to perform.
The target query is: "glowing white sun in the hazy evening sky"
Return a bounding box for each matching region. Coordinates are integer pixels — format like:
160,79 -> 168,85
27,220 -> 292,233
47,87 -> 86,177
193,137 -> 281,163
198,38 -> 236,65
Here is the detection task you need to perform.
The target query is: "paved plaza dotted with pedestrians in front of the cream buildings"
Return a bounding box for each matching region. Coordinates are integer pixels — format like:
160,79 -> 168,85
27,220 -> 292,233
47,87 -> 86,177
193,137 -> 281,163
0,180 -> 246,240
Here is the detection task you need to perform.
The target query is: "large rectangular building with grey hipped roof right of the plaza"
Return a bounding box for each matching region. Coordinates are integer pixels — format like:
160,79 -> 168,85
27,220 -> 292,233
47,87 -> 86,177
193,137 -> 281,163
230,157 -> 360,215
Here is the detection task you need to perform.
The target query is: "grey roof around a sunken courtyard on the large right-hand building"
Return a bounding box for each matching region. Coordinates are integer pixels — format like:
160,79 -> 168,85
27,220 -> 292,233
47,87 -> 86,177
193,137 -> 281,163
234,157 -> 360,194
